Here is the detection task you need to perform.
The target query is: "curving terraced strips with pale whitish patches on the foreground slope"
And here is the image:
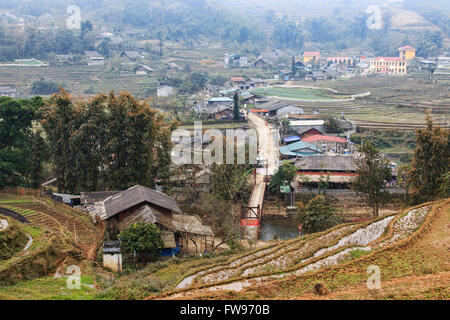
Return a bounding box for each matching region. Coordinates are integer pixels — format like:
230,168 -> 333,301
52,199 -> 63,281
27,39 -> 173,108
160,203 -> 448,298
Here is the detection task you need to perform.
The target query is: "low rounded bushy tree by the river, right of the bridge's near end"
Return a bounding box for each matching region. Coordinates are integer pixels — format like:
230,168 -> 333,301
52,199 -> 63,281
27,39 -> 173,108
293,195 -> 339,233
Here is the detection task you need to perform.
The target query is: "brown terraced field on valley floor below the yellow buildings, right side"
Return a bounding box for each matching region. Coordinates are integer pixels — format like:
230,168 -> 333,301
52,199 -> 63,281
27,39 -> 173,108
284,77 -> 450,126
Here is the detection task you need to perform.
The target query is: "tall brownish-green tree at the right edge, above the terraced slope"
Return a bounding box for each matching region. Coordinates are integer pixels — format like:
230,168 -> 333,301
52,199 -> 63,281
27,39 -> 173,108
408,113 -> 450,203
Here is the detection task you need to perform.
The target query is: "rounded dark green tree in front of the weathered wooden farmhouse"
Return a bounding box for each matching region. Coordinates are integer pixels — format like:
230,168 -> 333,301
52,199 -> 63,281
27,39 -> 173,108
118,222 -> 163,258
